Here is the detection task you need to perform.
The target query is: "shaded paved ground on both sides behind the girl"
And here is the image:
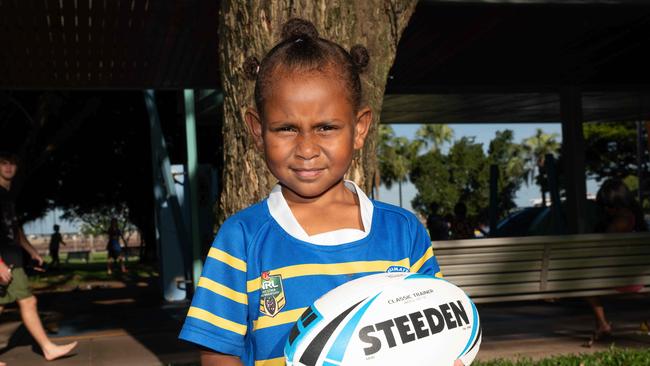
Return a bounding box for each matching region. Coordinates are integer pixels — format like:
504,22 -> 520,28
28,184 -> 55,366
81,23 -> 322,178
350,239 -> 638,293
0,285 -> 650,366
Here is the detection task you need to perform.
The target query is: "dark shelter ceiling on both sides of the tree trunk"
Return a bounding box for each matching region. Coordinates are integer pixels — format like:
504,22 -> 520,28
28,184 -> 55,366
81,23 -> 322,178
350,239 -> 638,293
0,0 -> 650,123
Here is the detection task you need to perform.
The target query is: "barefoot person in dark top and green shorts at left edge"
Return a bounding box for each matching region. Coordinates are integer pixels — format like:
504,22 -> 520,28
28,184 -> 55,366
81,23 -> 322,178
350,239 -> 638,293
0,153 -> 77,365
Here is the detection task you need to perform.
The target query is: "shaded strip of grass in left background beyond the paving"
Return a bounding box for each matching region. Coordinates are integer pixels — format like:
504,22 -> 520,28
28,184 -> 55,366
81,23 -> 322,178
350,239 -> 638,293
30,252 -> 158,292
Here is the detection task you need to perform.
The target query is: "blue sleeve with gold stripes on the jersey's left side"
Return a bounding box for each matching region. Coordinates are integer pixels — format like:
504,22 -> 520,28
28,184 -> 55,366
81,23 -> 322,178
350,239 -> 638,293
179,220 -> 248,357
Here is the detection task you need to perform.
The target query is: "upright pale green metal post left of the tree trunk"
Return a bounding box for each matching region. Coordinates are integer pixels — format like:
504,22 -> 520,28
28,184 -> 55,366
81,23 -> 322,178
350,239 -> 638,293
183,89 -> 202,288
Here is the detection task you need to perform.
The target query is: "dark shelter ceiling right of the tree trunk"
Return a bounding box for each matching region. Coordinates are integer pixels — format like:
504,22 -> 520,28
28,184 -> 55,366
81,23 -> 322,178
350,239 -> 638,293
381,0 -> 650,123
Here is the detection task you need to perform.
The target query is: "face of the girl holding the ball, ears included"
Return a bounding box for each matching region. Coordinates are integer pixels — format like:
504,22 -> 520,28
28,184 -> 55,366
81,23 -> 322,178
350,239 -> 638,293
246,72 -> 372,200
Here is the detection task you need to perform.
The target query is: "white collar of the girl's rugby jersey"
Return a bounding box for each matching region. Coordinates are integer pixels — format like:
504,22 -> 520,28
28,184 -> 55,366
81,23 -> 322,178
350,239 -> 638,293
267,180 -> 373,245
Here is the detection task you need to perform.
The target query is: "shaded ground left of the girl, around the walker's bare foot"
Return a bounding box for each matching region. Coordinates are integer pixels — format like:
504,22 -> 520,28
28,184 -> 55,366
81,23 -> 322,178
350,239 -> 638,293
0,263 -> 198,365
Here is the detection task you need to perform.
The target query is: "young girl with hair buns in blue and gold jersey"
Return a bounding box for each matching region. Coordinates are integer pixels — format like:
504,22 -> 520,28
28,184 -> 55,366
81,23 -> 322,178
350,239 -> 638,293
180,19 -> 440,366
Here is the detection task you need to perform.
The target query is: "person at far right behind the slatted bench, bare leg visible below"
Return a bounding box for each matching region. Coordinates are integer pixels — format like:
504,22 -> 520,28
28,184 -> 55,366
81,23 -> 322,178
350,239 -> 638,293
586,179 -> 648,345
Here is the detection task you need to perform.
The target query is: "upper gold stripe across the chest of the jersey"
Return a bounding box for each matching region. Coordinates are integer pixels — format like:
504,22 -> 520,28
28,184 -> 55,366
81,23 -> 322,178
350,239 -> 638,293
246,254 -> 408,292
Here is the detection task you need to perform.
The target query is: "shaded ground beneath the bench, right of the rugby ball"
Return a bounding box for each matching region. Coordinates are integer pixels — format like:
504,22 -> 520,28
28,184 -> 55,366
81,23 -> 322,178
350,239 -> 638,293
470,294 -> 650,362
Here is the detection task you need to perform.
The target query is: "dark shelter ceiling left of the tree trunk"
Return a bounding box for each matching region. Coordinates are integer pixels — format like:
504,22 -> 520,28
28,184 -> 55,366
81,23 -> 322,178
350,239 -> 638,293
0,0 -> 219,89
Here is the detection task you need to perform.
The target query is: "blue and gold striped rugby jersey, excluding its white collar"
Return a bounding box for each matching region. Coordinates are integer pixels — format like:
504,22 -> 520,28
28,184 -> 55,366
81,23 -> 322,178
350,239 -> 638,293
180,200 -> 441,366
